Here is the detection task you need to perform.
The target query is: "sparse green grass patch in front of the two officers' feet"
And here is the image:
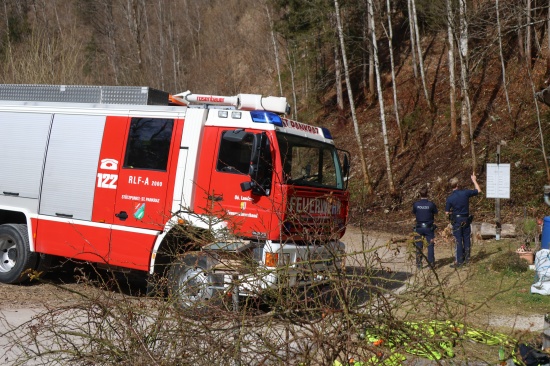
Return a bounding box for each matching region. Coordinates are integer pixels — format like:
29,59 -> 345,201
399,239 -> 550,329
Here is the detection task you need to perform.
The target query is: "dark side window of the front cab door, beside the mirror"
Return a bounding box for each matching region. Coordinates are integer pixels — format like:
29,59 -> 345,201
216,131 -> 253,174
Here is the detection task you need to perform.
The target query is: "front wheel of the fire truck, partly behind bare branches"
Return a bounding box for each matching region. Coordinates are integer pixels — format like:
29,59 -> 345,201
168,253 -> 213,309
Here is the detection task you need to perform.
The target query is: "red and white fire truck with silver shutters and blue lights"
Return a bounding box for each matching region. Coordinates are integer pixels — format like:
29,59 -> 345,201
0,84 -> 349,304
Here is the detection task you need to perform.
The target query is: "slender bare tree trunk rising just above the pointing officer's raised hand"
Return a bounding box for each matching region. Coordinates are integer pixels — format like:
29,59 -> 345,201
459,0 -> 477,172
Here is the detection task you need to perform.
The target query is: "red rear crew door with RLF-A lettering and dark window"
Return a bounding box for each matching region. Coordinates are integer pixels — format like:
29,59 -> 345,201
109,117 -> 182,270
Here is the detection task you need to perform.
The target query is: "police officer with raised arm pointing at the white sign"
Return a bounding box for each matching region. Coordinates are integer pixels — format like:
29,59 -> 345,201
445,174 -> 481,268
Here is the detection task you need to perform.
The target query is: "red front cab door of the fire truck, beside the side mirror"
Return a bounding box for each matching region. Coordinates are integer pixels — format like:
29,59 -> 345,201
196,128 -> 273,239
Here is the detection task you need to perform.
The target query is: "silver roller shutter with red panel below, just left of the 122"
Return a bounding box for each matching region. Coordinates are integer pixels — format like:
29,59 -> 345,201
36,114 -> 111,262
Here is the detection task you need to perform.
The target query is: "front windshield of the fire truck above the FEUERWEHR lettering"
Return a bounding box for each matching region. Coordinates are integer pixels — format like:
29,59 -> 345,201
277,132 -> 345,189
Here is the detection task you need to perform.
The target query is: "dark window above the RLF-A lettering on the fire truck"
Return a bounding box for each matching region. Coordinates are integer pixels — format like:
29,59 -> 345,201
124,117 -> 174,171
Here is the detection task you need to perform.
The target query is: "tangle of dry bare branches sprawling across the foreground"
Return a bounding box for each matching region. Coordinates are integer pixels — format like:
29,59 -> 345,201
0,234 -> 528,366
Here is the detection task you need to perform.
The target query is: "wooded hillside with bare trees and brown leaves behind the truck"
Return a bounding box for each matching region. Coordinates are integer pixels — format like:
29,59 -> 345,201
0,0 -> 550,230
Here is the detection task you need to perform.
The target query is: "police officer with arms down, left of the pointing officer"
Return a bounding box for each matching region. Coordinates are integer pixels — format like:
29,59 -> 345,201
413,187 -> 437,269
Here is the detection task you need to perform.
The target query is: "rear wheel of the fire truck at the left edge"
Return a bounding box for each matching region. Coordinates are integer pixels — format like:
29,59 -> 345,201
0,224 -> 37,284
